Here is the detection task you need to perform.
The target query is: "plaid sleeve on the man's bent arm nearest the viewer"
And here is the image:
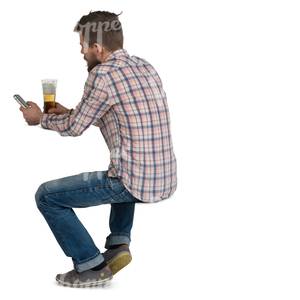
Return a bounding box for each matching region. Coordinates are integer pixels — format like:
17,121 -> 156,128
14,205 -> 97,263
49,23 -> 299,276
40,72 -> 110,136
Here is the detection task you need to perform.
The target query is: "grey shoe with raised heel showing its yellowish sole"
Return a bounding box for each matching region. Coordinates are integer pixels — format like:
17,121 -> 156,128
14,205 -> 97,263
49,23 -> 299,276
102,245 -> 132,275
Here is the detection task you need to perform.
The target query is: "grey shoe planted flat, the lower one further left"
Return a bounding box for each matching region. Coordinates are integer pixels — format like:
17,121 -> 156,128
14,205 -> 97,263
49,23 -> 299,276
56,266 -> 113,288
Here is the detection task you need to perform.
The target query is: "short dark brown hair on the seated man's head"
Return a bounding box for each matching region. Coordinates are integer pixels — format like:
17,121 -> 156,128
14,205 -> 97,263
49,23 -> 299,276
74,11 -> 124,51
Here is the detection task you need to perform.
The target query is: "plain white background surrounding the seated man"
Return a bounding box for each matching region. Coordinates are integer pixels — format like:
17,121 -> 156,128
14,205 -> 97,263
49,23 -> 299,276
0,0 -> 300,300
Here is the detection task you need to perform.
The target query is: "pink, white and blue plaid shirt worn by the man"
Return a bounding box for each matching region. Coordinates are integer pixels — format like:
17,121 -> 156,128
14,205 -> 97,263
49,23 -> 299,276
40,50 -> 177,202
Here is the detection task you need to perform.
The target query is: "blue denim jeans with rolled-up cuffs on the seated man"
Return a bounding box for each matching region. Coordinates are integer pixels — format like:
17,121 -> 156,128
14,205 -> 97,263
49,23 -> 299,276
35,171 -> 139,272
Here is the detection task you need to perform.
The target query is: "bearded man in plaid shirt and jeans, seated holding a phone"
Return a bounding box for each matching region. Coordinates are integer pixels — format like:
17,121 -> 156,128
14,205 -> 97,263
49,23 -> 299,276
20,11 -> 177,287
